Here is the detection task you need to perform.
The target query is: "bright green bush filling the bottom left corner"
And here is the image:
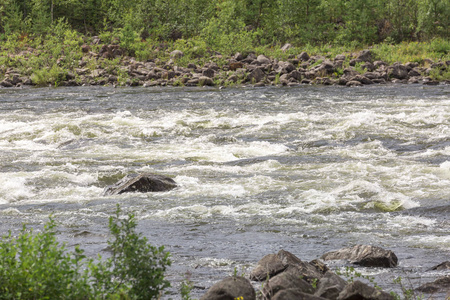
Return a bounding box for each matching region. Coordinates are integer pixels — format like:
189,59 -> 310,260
0,220 -> 90,299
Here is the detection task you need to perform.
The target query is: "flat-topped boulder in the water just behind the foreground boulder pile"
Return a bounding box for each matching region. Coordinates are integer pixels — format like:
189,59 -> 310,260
321,245 -> 398,268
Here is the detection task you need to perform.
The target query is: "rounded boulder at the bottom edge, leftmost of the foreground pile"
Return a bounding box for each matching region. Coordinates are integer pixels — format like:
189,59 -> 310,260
200,276 -> 256,300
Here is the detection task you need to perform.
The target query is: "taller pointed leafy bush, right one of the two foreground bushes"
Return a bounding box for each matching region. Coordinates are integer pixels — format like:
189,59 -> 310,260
89,206 -> 170,299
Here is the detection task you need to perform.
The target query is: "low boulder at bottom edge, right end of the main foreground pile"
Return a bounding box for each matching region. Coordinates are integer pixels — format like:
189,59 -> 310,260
337,281 -> 395,300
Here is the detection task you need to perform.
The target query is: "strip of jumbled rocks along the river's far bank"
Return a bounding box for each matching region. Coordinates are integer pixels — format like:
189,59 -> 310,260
0,39 -> 450,87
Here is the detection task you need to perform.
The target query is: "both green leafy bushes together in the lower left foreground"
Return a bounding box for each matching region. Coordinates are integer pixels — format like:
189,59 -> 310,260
0,207 -> 170,299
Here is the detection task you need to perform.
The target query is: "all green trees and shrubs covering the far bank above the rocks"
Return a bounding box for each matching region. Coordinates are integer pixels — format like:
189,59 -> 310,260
0,0 -> 450,85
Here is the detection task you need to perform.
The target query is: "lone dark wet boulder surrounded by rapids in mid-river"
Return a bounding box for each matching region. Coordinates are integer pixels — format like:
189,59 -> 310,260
103,173 -> 177,196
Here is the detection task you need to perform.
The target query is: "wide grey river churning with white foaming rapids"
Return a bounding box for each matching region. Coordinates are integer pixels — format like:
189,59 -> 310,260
0,85 -> 450,299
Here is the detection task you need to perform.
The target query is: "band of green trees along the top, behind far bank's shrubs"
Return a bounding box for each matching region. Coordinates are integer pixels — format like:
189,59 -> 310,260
0,0 -> 450,47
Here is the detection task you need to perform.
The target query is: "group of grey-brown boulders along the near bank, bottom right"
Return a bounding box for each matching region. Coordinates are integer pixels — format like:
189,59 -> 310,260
201,245 -> 450,300
